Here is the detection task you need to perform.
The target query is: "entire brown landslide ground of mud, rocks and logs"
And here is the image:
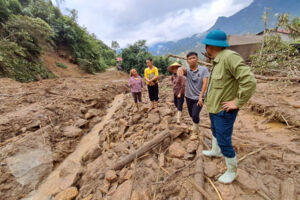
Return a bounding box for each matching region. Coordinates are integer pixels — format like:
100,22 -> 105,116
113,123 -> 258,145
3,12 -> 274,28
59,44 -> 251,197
0,72 -> 300,200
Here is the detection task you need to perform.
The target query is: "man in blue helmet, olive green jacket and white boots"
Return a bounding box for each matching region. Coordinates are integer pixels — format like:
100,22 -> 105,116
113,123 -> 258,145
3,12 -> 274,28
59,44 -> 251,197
202,30 -> 256,183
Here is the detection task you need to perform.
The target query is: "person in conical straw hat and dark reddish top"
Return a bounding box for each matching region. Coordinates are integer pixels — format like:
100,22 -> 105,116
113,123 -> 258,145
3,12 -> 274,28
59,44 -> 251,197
168,62 -> 186,124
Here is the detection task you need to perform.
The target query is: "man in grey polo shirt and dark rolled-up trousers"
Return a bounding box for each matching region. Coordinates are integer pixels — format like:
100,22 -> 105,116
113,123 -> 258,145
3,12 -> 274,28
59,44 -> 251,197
179,52 -> 209,140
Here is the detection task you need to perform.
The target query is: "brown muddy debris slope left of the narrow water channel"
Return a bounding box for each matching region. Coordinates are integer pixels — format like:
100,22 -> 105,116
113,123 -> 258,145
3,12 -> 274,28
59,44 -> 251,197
0,71 -> 129,200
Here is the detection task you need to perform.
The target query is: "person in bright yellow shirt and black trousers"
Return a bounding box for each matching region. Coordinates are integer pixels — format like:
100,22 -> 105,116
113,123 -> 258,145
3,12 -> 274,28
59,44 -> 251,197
145,58 -> 159,111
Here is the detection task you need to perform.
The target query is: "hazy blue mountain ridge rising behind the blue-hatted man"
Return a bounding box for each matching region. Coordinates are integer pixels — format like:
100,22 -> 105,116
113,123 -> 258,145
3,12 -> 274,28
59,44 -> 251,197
149,0 -> 300,55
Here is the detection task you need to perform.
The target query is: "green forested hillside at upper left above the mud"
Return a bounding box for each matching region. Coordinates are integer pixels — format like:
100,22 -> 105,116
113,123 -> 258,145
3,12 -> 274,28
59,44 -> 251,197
0,0 -> 115,82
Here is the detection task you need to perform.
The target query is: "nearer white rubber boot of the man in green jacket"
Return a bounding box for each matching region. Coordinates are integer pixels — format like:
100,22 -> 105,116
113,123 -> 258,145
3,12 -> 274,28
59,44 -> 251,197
218,156 -> 237,184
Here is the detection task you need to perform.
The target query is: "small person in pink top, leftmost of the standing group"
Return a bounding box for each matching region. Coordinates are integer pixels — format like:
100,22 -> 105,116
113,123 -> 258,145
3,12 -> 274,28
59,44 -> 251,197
128,69 -> 143,111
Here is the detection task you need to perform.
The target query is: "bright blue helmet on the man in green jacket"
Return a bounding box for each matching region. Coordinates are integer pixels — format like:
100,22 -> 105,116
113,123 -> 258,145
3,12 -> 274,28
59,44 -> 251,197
202,30 -> 229,47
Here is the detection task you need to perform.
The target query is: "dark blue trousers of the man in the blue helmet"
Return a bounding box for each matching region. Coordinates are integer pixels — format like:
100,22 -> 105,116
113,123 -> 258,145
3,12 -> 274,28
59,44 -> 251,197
209,110 -> 239,158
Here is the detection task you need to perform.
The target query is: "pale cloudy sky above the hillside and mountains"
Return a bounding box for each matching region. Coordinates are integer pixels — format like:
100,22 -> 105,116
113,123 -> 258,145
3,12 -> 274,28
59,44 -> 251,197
61,0 -> 253,47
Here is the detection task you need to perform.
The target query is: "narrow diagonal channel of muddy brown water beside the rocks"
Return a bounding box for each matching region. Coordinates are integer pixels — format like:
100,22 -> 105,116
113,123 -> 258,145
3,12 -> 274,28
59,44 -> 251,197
28,94 -> 124,200
